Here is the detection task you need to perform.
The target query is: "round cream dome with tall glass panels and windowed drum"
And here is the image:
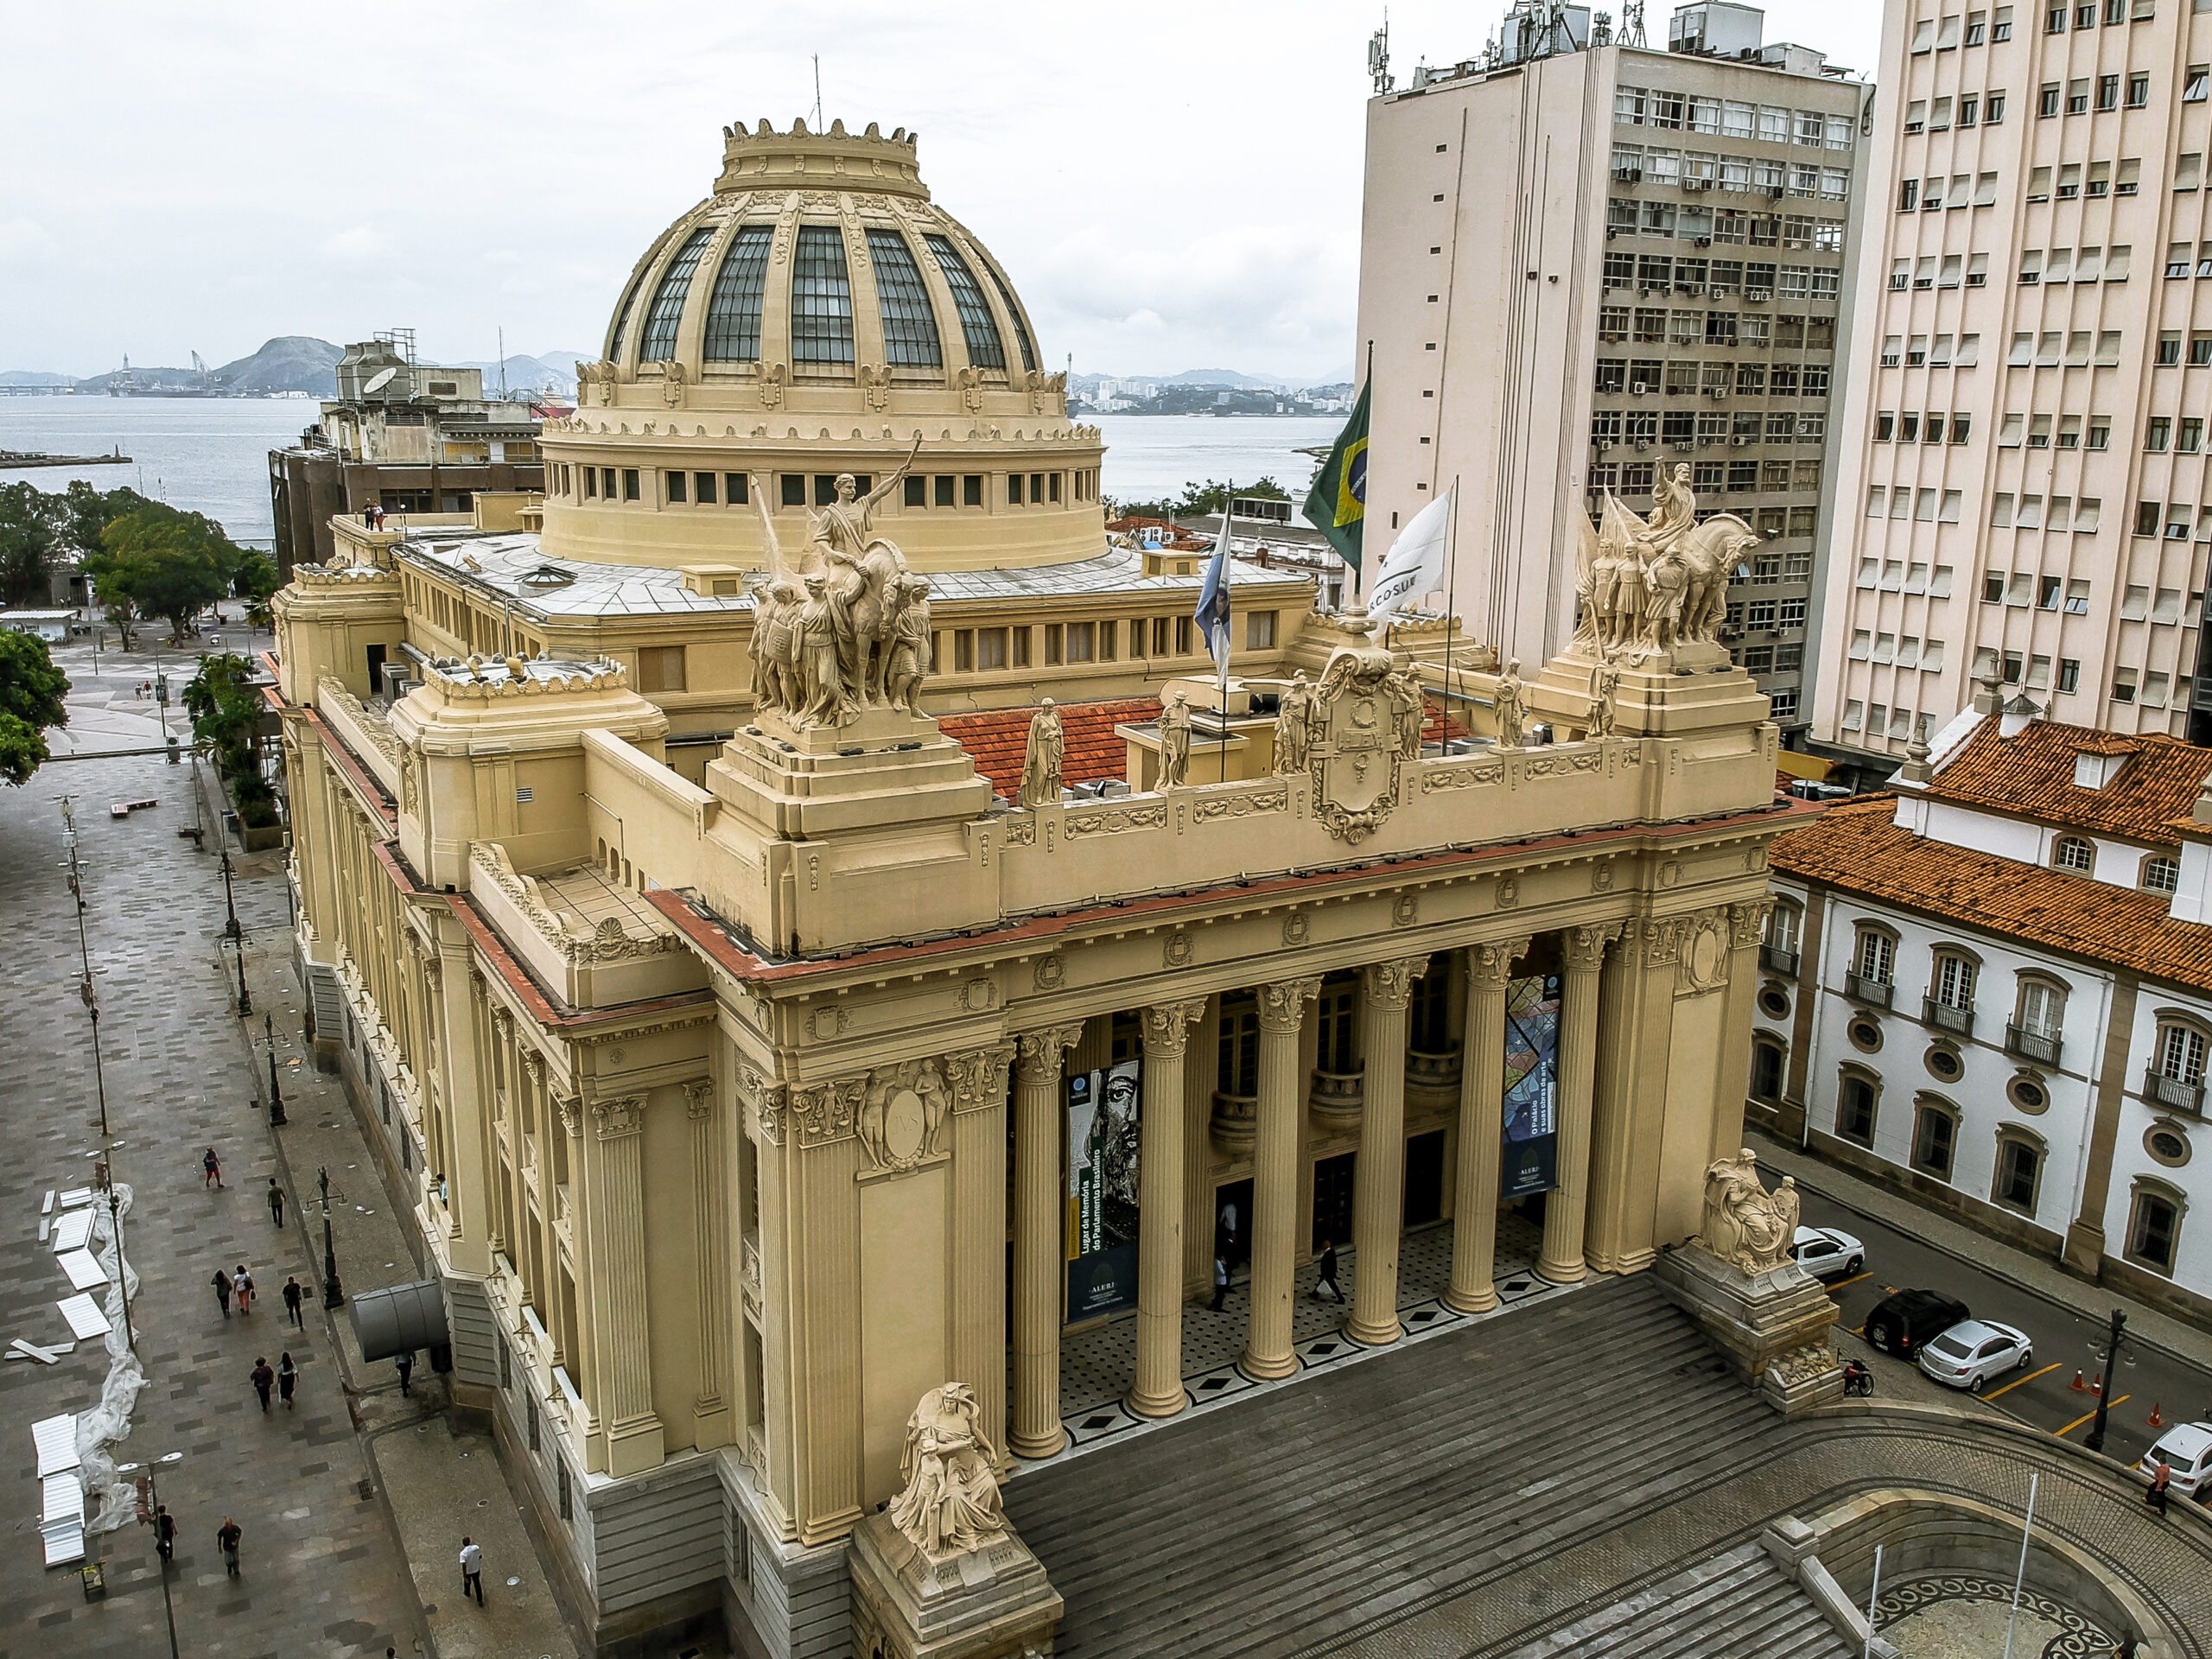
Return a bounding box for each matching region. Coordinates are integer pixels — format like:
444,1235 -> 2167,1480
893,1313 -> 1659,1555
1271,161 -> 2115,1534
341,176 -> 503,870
526,122 -> 1103,570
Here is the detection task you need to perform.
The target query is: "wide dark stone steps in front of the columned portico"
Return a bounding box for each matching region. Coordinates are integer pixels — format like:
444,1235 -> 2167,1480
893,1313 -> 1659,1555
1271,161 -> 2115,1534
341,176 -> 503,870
1007,1281 -> 1792,1659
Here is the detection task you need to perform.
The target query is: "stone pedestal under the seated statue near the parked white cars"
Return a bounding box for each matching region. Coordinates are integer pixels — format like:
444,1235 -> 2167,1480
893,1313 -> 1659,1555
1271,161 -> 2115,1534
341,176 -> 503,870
1652,1243 -> 1842,1418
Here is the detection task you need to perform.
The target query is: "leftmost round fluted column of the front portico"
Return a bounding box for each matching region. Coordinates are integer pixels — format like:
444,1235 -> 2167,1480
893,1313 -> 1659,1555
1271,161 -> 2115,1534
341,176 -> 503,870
1007,1024 -> 1084,1458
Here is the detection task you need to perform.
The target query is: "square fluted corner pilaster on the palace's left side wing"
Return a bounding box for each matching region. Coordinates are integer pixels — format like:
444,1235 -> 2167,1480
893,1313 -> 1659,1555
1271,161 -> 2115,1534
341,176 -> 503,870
591,1095 -> 661,1476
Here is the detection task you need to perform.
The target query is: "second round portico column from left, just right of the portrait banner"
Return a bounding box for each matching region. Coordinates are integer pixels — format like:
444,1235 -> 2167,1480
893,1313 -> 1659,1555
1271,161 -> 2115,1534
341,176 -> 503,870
1128,998 -> 1205,1418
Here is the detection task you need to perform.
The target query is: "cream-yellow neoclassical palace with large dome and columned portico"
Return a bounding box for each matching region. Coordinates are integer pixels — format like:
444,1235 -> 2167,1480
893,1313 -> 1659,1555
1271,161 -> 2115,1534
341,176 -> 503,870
272,111 -> 1802,1655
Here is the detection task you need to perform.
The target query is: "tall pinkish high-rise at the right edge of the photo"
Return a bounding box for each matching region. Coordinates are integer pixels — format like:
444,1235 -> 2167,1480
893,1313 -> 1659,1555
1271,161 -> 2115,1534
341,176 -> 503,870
1814,0 -> 2212,772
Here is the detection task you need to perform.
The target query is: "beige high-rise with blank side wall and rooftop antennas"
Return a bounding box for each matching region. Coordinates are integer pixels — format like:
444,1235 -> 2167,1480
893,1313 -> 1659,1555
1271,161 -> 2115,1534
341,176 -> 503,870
1360,0 -> 1869,730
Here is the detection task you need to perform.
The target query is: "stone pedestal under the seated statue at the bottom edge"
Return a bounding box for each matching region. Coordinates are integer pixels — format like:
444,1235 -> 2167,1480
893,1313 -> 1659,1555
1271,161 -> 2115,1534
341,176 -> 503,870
849,1516 -> 1064,1659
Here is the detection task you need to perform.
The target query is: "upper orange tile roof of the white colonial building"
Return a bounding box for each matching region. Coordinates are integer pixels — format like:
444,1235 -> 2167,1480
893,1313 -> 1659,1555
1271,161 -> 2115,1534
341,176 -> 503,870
1927,719 -> 2212,847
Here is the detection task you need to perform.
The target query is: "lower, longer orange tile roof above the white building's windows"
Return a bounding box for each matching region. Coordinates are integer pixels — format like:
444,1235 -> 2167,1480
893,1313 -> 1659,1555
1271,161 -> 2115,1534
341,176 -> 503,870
1772,800 -> 2212,991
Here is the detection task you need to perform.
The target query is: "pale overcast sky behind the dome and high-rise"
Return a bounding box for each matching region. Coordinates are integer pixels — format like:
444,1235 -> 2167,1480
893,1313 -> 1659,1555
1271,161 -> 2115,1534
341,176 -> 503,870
0,0 -> 1880,378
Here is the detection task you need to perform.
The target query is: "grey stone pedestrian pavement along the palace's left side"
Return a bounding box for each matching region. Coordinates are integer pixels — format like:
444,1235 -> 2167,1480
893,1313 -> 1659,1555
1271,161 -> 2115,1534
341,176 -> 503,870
0,752 -> 420,1659
